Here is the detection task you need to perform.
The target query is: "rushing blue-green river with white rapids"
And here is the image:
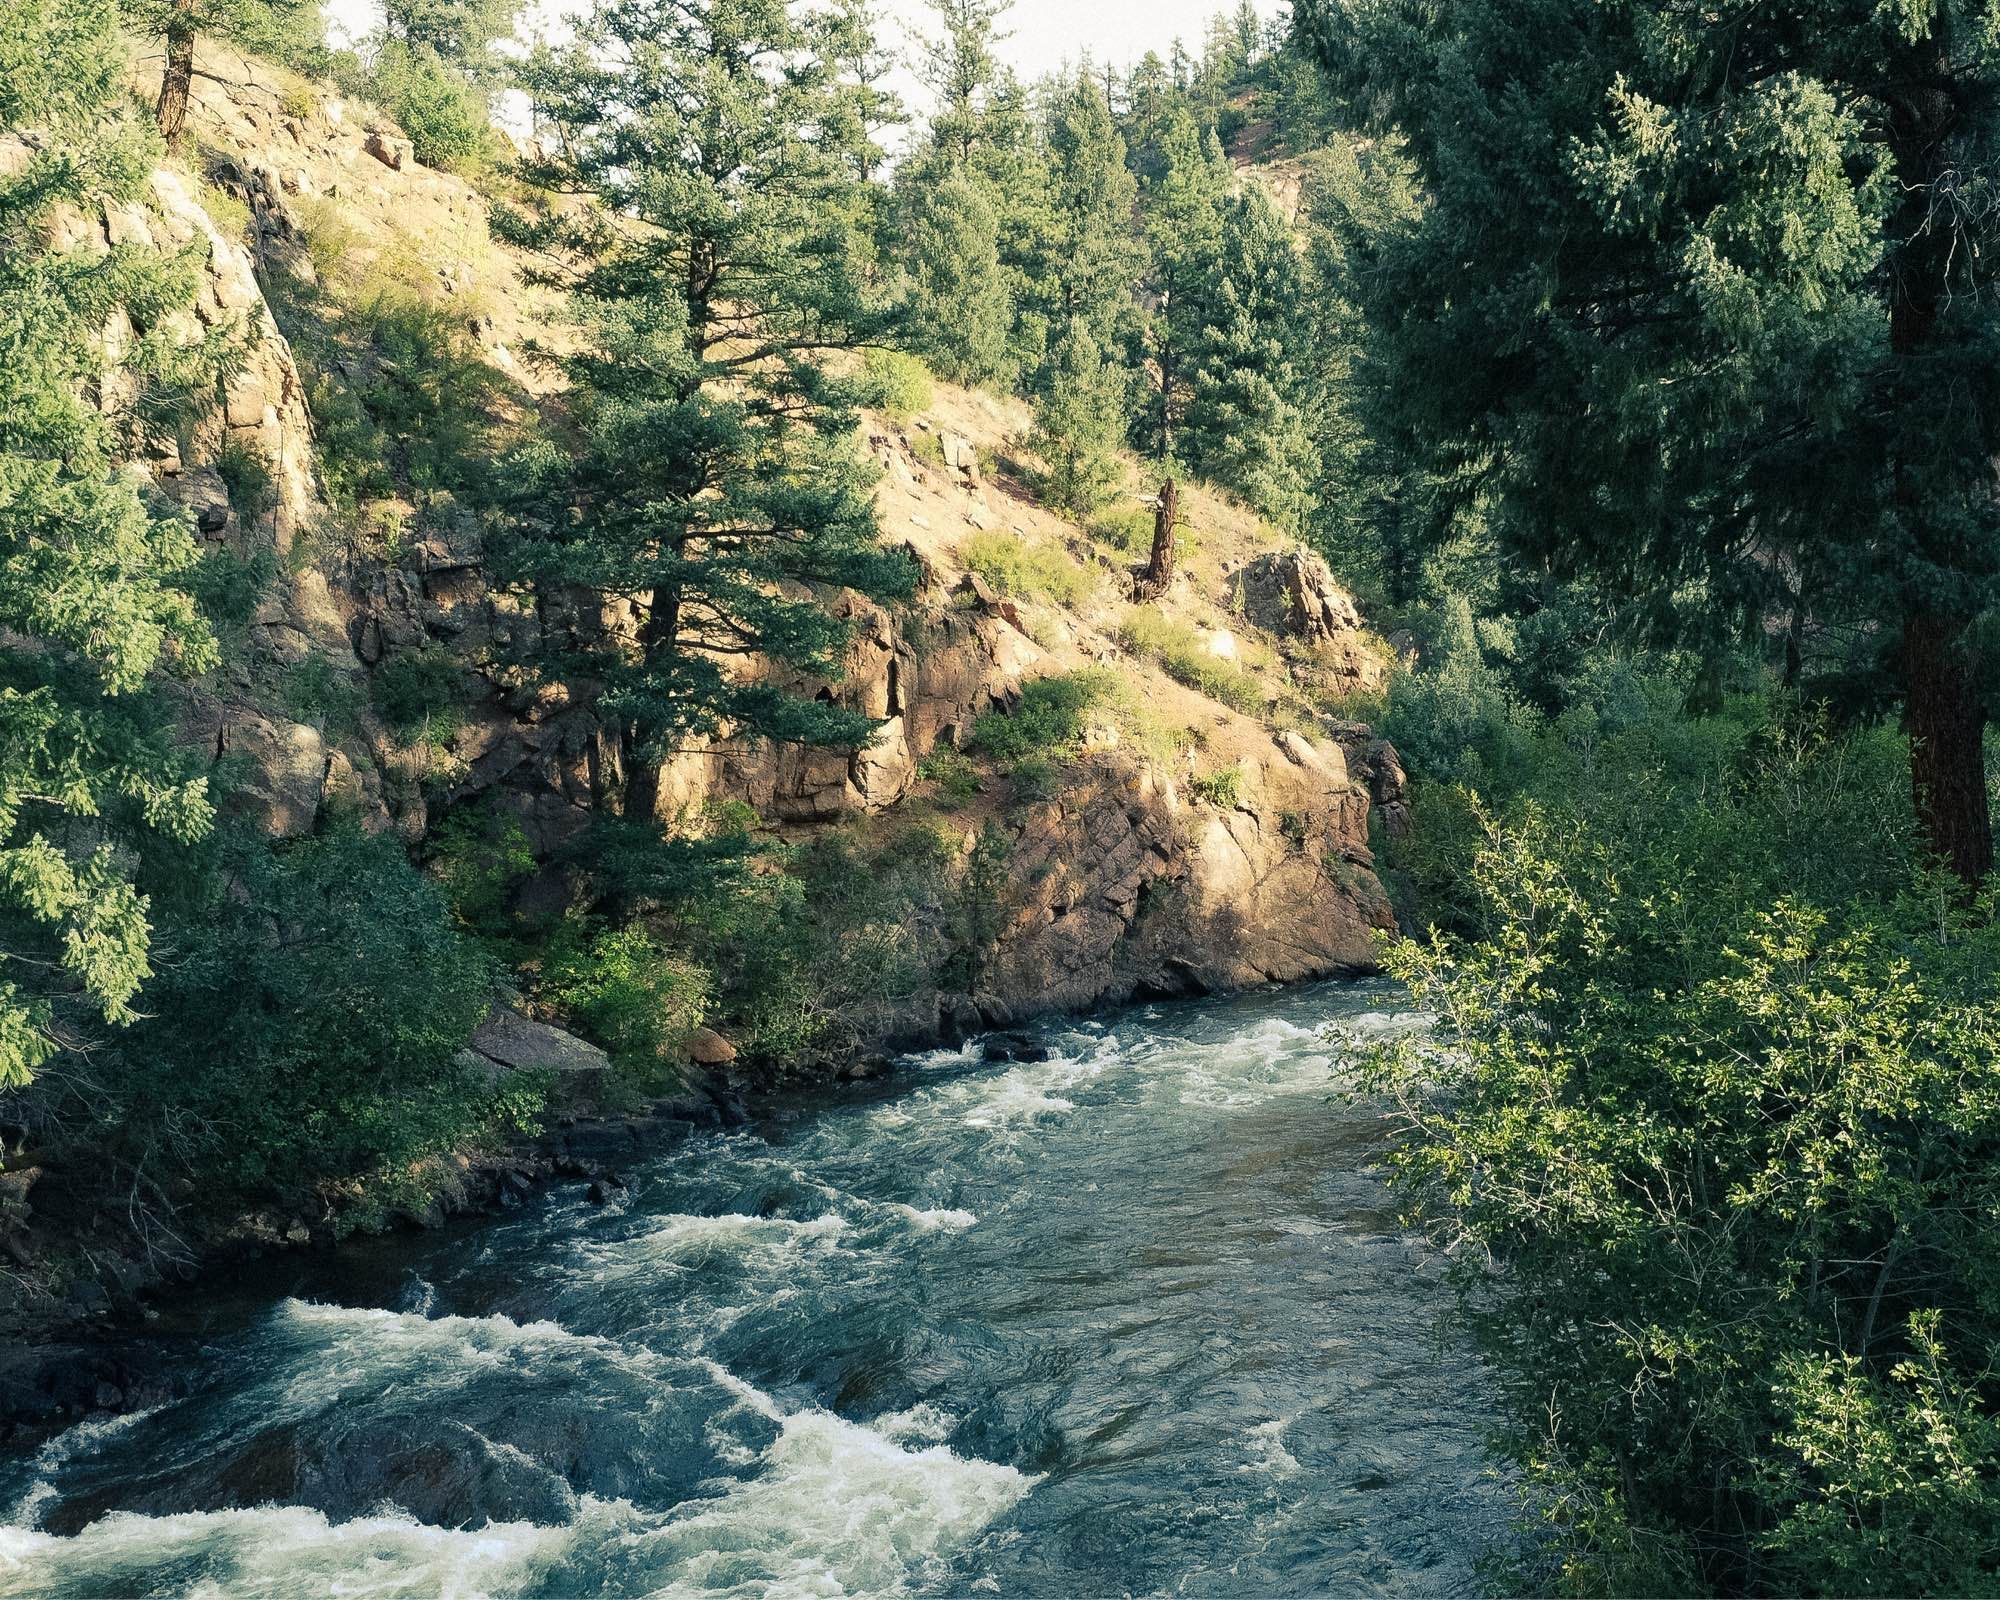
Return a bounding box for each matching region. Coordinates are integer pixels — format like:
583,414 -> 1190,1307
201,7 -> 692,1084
0,984 -> 1506,1598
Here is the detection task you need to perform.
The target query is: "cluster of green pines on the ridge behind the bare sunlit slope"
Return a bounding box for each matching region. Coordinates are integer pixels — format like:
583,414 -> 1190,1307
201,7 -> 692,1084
884,0 -> 1326,528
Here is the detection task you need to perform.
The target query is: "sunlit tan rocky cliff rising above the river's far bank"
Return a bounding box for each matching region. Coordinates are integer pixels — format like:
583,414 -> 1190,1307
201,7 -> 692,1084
102,40 -> 1400,1030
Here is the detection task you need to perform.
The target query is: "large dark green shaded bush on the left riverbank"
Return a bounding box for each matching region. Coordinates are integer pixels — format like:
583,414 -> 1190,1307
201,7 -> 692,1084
103,826 -> 494,1196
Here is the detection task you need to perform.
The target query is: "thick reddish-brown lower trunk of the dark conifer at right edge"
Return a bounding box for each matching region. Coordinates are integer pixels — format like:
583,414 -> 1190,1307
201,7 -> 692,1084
1902,612 -> 1994,884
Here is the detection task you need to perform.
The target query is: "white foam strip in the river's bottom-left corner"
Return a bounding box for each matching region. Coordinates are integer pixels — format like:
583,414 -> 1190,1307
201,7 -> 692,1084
0,1506 -> 574,1600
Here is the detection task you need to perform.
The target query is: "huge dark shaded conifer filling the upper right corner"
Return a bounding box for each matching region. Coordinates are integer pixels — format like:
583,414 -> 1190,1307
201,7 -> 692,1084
1300,0 -> 2000,882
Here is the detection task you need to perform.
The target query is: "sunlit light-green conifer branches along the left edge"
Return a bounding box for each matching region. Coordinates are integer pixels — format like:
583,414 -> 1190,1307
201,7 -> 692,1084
0,0 -> 216,1088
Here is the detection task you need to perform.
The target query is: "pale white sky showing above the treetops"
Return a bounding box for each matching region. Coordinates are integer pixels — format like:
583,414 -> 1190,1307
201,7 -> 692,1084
326,0 -> 1280,119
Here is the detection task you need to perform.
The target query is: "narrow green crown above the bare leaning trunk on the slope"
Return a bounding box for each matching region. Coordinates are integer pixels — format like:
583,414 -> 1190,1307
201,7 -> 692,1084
1140,106 -> 1230,460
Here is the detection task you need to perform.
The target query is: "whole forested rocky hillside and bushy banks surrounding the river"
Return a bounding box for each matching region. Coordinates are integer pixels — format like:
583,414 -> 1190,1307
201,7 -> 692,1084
0,0 -> 2000,1594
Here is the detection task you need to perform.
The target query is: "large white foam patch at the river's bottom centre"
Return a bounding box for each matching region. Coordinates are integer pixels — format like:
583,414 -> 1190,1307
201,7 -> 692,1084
628,1364 -> 1040,1600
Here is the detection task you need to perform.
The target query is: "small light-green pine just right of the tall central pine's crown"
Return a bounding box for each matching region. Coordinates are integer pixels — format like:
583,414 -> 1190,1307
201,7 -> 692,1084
896,172 -> 1014,384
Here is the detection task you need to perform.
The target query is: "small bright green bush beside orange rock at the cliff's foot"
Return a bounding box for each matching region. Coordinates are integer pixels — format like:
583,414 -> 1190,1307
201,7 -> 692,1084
536,918 -> 716,1092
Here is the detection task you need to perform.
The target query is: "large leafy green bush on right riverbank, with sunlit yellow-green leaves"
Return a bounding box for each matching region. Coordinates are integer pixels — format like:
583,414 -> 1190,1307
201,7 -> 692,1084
1368,712 -> 2000,1594
